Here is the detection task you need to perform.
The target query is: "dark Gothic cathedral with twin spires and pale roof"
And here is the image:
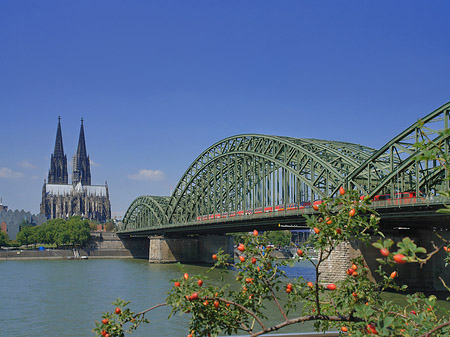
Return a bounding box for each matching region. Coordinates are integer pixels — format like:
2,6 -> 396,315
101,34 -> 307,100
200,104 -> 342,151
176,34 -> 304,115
41,117 -> 111,222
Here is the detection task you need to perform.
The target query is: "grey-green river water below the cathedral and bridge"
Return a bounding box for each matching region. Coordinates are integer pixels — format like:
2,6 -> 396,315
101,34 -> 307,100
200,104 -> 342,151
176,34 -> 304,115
0,259 -> 314,337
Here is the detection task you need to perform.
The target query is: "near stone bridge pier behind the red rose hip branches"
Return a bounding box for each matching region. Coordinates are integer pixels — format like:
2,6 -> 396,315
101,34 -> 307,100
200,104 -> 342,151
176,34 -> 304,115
320,228 -> 450,293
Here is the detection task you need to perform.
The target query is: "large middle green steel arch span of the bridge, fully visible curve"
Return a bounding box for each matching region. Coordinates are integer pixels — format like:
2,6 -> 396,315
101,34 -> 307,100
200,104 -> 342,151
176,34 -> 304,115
167,134 -> 375,223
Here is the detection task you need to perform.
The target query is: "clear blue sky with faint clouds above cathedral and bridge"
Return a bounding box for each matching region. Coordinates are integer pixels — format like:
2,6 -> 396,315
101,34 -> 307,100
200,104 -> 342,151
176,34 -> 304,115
0,0 -> 450,218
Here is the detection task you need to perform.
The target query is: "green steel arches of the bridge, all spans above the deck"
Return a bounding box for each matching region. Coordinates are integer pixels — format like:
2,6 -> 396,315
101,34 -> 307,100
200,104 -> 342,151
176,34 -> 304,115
124,102 -> 450,230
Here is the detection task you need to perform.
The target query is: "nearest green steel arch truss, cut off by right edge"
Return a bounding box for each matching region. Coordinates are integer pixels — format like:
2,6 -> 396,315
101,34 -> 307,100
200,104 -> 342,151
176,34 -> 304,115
347,103 -> 450,197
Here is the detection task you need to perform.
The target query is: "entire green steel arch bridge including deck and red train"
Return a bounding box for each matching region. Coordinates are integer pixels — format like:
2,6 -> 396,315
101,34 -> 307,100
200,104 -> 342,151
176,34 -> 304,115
118,102 -> 450,236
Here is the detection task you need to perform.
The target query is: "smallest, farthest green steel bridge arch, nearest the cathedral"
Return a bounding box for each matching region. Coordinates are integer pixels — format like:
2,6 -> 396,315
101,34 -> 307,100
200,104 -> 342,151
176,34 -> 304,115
121,195 -> 170,231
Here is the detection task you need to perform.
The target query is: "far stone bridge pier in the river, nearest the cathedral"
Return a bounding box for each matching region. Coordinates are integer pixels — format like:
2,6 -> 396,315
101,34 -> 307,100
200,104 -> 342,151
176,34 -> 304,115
149,235 -> 233,263
